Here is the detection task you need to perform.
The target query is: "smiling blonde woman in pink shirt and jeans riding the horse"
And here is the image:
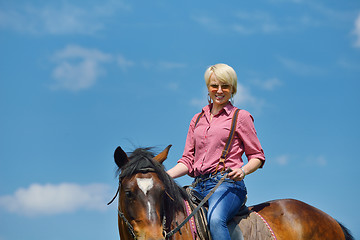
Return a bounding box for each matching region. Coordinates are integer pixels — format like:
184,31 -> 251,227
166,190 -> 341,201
168,64 -> 265,240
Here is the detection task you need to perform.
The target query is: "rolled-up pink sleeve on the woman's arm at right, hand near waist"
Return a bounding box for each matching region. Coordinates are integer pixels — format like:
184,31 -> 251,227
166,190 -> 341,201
236,110 -> 265,167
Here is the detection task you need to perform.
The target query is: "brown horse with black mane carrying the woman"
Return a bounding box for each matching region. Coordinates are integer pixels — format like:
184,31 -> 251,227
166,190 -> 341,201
109,145 -> 354,240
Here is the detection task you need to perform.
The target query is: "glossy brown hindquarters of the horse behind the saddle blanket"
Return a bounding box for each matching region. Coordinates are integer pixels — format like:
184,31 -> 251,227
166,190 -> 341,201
250,199 -> 345,240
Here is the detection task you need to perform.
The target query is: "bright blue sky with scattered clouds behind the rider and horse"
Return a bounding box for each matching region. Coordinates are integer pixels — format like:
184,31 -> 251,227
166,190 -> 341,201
0,0 -> 360,240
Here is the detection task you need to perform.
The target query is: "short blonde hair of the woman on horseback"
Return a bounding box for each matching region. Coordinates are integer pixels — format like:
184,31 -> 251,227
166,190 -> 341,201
204,63 -> 237,95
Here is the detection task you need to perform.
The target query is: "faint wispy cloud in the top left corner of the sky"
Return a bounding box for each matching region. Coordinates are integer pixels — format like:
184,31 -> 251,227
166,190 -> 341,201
0,1 -> 129,35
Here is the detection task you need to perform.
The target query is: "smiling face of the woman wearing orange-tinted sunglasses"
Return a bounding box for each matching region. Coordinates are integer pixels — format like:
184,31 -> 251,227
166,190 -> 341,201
208,74 -> 232,106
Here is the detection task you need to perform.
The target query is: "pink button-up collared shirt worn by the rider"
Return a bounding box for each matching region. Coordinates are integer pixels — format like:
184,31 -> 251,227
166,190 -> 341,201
178,102 -> 265,177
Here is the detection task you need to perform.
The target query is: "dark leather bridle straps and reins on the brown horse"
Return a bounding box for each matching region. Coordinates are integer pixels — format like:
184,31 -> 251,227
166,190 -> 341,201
107,168 -> 231,240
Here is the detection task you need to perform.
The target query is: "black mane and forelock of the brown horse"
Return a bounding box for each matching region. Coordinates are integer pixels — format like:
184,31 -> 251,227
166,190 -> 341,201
118,148 -> 188,216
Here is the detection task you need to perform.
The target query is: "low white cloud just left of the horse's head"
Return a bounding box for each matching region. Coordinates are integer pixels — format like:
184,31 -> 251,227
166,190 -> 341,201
0,183 -> 109,216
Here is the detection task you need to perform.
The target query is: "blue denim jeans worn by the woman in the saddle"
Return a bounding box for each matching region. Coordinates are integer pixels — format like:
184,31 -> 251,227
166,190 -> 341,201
194,173 -> 247,240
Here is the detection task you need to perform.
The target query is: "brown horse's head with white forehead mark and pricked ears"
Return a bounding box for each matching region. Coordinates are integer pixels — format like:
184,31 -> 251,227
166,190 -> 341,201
114,145 -> 187,240
